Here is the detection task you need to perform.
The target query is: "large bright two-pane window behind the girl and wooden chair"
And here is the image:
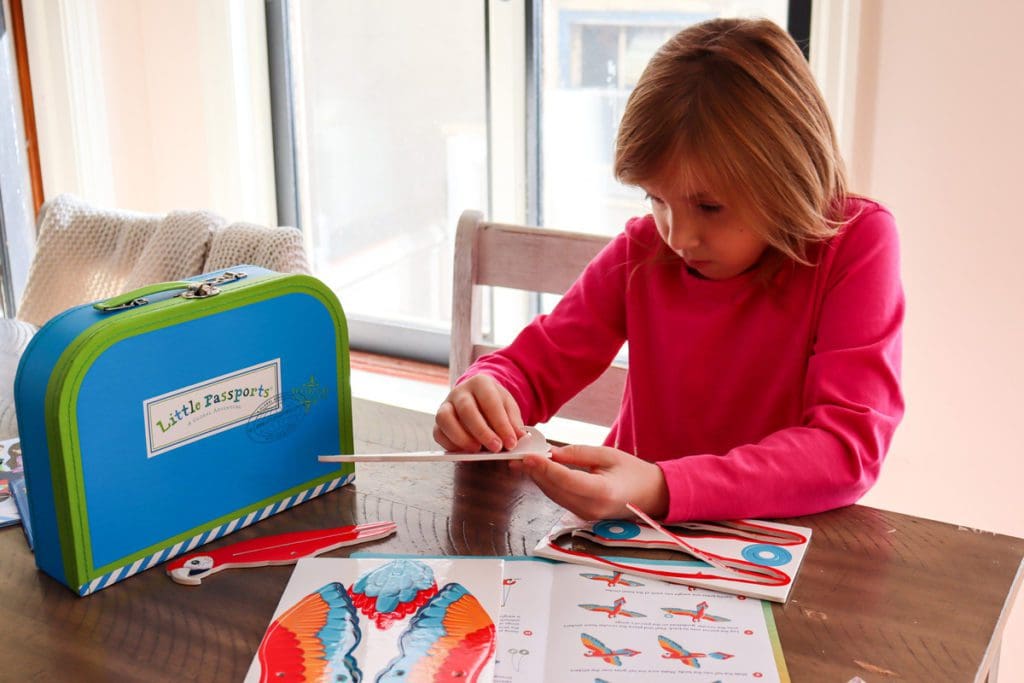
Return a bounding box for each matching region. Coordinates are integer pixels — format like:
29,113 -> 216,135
268,0 -> 801,362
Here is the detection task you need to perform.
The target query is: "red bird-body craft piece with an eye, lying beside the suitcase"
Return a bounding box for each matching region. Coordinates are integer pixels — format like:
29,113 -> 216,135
166,521 -> 397,586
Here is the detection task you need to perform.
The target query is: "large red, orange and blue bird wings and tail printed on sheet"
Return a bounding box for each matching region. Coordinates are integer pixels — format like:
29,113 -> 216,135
257,560 -> 497,683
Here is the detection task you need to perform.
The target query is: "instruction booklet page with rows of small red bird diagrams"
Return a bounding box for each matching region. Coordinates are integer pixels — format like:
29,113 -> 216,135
495,558 -> 790,683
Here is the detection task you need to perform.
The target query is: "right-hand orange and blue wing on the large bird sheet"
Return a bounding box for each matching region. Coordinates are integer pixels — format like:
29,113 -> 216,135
377,584 -> 496,683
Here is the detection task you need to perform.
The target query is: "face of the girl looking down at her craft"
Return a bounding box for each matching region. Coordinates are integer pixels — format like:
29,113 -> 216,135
640,163 -> 768,280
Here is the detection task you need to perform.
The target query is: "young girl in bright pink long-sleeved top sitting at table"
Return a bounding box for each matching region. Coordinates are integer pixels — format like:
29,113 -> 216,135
434,19 -> 903,522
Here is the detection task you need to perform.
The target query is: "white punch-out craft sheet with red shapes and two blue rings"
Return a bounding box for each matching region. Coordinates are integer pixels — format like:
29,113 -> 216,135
532,506 -> 811,602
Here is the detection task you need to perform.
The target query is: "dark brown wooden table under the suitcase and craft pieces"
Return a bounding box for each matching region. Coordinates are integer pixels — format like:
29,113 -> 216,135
0,401 -> 1024,683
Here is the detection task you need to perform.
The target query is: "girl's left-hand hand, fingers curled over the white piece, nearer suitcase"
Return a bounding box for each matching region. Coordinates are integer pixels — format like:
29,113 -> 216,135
434,374 -> 526,453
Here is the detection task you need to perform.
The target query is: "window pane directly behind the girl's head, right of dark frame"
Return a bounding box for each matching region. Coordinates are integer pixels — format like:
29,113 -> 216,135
540,0 -> 788,234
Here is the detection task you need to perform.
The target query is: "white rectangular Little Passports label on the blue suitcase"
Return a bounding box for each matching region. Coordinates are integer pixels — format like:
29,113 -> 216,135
142,358 -> 282,458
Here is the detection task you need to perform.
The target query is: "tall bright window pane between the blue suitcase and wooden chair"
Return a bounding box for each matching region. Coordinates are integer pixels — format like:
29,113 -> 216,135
292,0 -> 487,330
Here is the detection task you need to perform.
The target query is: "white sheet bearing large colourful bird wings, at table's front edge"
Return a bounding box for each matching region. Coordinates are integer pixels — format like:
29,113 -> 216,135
246,557 -> 502,682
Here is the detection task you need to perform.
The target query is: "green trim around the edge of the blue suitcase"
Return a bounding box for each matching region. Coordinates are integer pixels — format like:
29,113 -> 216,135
44,274 -> 354,586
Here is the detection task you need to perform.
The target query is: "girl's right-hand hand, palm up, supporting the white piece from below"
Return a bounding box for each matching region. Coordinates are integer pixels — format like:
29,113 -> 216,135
510,445 -> 669,519
